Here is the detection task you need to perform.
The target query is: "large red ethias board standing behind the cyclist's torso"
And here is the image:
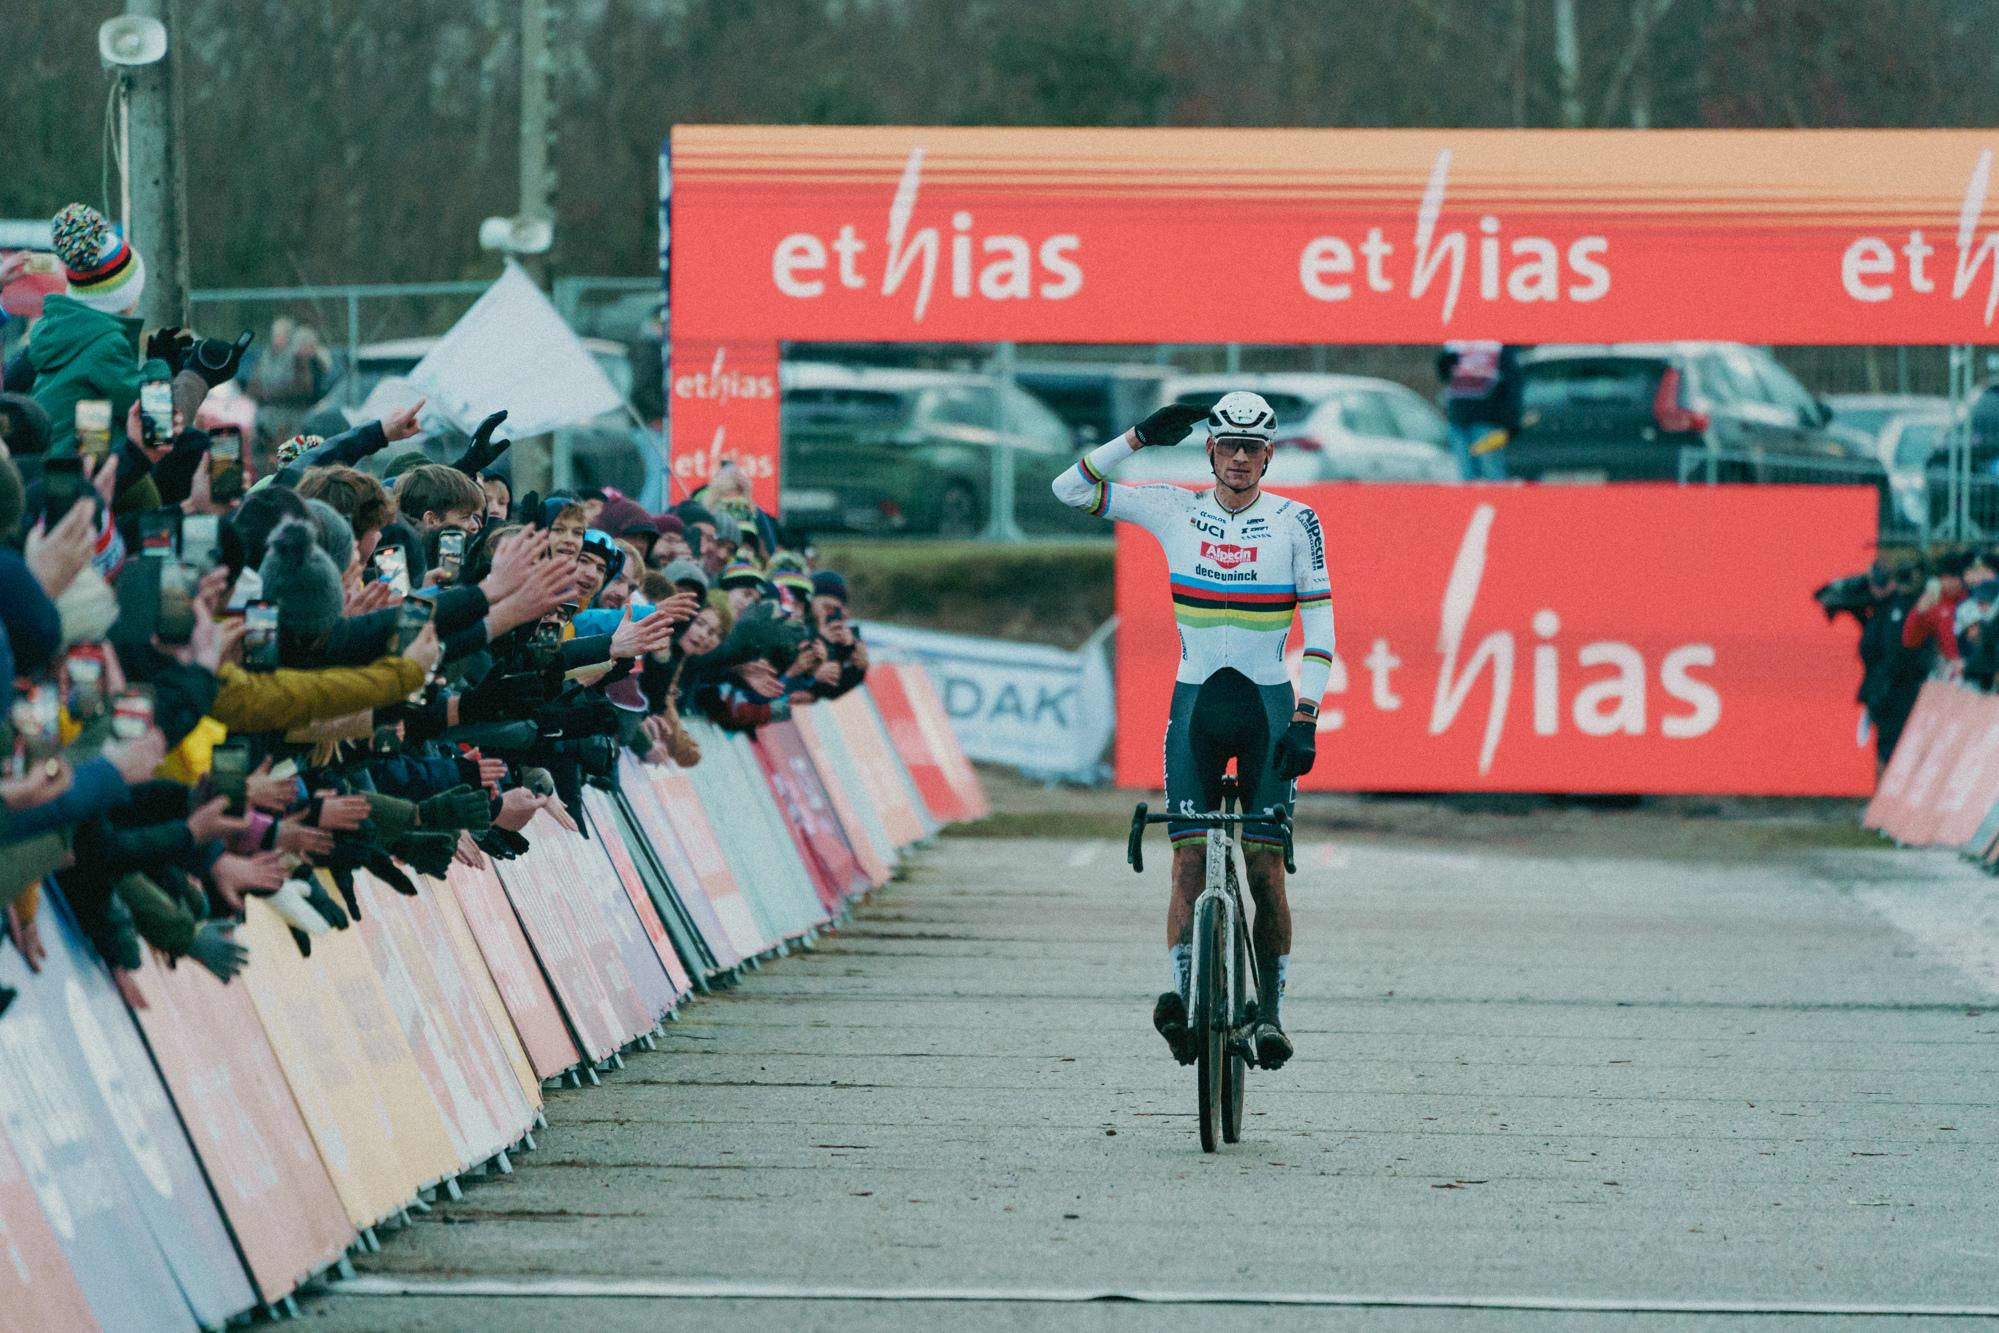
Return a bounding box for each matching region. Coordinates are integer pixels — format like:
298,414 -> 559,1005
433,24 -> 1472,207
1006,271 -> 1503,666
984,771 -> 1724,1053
1117,484 -> 1877,795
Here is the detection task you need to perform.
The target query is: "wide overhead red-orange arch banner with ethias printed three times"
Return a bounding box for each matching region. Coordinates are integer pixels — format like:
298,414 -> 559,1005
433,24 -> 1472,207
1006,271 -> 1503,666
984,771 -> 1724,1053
672,126 -> 1999,343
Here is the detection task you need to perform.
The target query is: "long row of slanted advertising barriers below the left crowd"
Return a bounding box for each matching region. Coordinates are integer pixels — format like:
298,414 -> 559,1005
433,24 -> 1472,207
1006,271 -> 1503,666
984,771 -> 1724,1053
0,664 -> 988,1333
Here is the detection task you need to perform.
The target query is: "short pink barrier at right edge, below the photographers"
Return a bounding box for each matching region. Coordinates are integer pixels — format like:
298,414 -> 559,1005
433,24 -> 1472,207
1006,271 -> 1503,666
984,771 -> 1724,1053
1861,679 -> 1999,865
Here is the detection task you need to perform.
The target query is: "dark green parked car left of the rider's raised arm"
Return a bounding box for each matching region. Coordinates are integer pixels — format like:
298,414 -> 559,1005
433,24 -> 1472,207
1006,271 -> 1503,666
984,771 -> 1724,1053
780,362 -> 1101,538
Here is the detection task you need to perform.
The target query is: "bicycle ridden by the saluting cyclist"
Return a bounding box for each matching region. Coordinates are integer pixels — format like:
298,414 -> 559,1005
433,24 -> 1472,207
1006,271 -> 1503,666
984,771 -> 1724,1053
1125,773 -> 1297,1153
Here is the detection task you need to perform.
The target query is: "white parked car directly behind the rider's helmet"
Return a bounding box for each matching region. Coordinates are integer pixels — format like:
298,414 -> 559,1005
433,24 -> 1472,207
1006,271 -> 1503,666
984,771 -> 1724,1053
1117,374 -> 1459,486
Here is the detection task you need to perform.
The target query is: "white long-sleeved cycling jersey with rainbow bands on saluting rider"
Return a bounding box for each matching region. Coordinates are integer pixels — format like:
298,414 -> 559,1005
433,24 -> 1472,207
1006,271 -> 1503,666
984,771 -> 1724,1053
1053,432 -> 1333,703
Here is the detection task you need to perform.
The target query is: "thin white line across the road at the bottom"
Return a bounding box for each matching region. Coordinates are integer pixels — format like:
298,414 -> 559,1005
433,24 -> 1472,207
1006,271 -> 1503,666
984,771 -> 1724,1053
326,1277 -> 1999,1319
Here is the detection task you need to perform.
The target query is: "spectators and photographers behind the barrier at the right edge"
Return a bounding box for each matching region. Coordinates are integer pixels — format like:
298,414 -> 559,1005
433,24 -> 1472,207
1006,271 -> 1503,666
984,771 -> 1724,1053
1817,550 -> 1999,765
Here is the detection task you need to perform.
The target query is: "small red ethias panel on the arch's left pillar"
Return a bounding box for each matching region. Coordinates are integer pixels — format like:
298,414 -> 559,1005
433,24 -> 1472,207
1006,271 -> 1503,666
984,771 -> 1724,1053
666,336 -> 778,514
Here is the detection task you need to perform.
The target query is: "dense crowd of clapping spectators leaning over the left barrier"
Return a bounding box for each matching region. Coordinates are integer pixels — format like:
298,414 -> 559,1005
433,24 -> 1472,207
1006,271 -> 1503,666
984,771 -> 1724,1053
0,204 -> 868,1009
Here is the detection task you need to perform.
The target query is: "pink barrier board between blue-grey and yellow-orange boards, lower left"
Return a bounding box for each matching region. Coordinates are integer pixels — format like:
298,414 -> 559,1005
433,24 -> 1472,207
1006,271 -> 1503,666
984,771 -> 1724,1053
134,949 -> 354,1303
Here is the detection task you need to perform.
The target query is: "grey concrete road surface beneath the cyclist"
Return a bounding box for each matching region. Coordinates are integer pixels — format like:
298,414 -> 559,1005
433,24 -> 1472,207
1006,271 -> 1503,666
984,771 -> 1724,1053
308,811 -> 1999,1333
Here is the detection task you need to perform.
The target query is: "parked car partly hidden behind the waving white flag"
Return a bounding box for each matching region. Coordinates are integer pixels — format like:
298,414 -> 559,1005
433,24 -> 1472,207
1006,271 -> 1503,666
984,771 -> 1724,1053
306,338 -> 664,496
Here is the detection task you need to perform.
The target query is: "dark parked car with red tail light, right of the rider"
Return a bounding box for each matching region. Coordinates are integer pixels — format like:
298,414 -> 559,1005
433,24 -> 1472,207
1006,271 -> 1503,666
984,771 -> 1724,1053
1507,342 -> 1877,482
